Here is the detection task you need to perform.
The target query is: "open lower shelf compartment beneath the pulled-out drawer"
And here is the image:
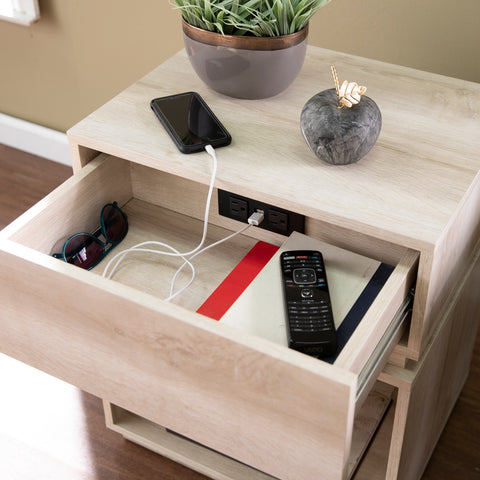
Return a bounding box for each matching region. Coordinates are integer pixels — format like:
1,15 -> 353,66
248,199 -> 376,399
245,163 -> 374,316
104,382 -> 395,480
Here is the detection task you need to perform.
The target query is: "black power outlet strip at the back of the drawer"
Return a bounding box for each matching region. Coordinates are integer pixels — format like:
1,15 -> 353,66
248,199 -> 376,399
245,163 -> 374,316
218,190 -> 305,235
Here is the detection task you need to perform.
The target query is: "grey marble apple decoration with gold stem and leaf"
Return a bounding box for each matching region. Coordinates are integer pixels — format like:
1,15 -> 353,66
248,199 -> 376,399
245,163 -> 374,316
300,67 -> 382,165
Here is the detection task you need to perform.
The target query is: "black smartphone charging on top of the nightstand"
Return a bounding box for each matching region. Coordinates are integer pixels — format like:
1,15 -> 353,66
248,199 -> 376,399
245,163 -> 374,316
150,92 -> 232,153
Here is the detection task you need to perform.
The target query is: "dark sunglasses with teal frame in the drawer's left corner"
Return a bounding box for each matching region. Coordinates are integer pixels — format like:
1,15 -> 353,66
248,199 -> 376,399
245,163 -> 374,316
52,202 -> 128,270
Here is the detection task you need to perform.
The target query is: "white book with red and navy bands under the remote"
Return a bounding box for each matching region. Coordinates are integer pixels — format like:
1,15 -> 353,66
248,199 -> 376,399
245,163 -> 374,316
198,232 -> 393,363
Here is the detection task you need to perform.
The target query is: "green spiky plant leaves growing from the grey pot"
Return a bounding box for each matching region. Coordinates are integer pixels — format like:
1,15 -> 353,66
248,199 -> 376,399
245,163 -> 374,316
173,0 -> 330,37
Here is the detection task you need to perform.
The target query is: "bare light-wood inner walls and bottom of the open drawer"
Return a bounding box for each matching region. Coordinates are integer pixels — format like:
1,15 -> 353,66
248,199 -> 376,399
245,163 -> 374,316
3,155 -> 417,376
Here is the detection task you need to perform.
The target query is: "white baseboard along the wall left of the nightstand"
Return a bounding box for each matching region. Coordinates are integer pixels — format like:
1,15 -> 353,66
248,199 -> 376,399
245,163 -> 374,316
0,113 -> 72,166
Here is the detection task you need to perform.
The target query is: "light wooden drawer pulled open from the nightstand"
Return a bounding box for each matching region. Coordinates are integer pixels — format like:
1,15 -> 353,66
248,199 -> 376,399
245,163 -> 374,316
0,155 -> 418,480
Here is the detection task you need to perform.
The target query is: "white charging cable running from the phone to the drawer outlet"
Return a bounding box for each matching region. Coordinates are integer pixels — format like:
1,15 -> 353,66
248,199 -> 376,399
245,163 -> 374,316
103,145 -> 263,301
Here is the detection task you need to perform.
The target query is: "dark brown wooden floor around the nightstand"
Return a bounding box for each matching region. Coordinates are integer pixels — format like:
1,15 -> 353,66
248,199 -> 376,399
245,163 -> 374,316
0,145 -> 480,480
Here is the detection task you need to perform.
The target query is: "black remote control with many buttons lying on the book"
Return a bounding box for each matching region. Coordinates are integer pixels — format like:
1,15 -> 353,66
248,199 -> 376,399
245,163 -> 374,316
280,250 -> 337,357
